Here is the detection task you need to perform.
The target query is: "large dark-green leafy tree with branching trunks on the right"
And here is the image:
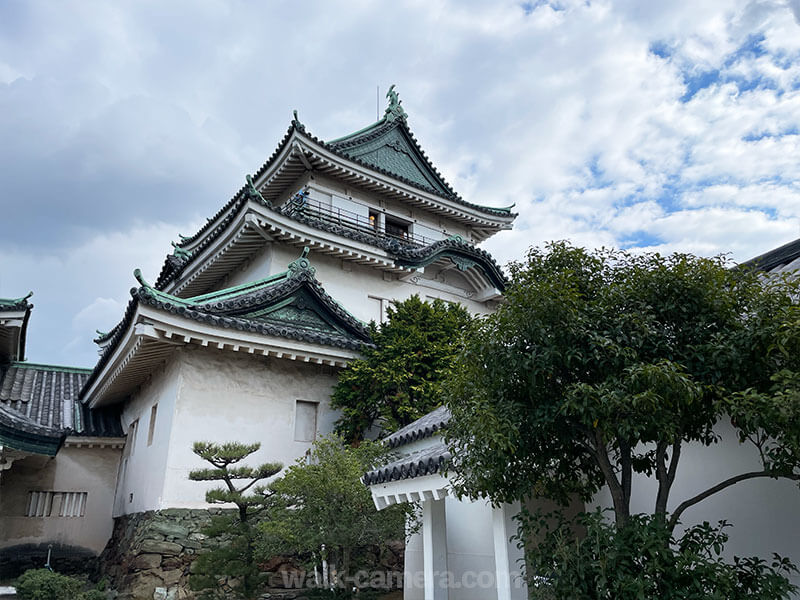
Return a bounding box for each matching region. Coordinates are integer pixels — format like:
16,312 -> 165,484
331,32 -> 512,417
447,243 -> 800,596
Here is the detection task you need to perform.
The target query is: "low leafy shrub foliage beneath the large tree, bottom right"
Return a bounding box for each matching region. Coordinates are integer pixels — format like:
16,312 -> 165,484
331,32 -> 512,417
522,512 -> 797,600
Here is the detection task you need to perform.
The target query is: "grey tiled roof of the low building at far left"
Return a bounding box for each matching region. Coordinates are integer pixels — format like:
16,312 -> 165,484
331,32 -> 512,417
0,362 -> 123,454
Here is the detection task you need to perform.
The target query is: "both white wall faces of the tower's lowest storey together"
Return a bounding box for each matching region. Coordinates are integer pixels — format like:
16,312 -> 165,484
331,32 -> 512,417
117,346 -> 336,514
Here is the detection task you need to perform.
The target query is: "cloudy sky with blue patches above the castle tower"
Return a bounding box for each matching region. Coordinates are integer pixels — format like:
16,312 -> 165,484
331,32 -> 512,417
0,0 -> 800,367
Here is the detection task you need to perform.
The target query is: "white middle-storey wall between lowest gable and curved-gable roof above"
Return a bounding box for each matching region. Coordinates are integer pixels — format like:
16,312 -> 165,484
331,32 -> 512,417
224,244 -> 490,322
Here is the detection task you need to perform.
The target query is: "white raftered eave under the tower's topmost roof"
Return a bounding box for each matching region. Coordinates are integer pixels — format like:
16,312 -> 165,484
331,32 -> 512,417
254,130 -> 515,234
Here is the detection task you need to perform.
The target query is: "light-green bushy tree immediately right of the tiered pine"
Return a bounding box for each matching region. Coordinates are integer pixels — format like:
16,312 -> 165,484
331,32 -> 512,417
259,435 -> 413,581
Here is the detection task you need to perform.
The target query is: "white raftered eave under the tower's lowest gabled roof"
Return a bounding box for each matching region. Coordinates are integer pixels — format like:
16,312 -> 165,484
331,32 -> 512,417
84,304 -> 358,408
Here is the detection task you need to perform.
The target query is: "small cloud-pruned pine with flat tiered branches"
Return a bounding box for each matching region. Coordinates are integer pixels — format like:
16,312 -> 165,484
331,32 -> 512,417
189,442 -> 283,600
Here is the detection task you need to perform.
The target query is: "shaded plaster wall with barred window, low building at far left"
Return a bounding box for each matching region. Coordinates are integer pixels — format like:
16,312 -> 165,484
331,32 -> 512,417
0,446 -> 120,554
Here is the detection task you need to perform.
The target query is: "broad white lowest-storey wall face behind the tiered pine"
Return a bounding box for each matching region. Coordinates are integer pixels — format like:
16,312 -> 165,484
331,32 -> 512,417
160,347 -> 337,508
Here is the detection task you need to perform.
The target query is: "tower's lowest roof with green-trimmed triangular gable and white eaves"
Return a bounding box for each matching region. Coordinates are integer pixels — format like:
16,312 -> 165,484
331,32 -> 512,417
81,248 -> 371,406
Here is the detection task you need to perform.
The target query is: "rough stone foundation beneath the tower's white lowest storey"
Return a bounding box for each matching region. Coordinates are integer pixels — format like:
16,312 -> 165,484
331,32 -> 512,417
99,508 -> 404,600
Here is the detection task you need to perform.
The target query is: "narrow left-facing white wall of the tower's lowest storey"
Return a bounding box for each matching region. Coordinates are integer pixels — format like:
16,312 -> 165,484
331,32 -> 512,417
114,356 -> 181,517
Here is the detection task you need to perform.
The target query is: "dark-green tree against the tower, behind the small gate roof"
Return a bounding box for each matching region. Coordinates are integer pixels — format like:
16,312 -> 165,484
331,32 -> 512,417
331,295 -> 470,442
